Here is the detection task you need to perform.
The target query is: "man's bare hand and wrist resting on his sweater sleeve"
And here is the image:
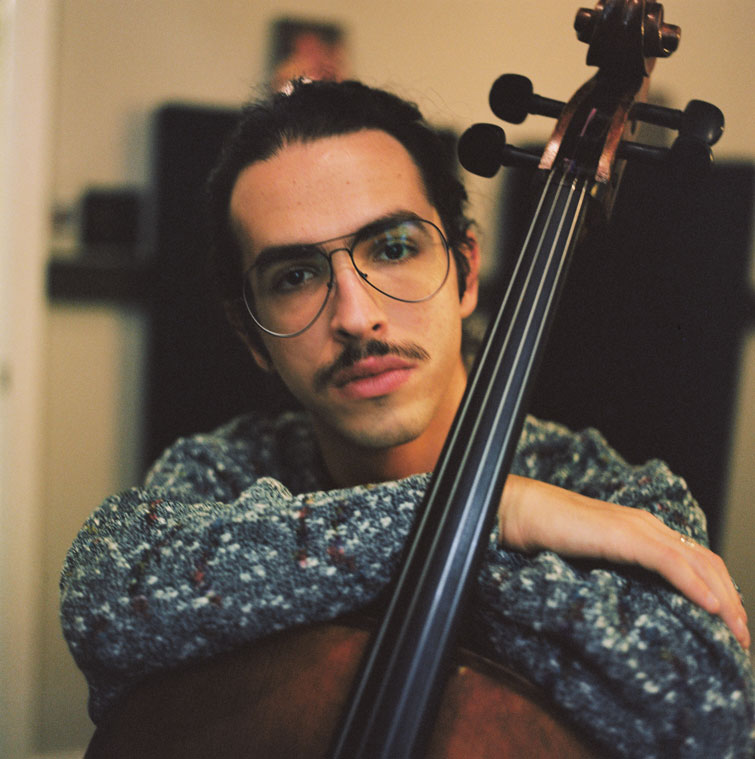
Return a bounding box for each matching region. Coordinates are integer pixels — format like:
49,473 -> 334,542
498,475 -> 750,648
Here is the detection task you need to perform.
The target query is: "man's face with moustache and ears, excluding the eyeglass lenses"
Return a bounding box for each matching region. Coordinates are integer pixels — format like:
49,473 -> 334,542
231,130 -> 478,466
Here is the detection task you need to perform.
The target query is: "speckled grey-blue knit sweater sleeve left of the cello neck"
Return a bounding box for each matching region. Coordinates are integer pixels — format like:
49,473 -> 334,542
61,440 -> 427,723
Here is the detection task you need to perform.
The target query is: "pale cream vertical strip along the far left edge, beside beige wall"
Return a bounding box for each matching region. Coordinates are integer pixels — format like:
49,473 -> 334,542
0,0 -> 53,759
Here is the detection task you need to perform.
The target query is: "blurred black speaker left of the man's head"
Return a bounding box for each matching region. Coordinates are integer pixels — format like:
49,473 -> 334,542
145,104 -> 292,465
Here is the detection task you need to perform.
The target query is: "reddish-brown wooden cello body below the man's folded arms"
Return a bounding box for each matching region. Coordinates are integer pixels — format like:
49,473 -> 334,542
86,621 -> 600,759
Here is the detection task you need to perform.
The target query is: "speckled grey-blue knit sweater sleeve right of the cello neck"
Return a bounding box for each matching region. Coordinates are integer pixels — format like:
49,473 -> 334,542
466,418 -> 755,759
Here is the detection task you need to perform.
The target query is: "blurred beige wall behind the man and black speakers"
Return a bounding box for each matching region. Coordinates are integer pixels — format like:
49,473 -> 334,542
0,0 -> 755,756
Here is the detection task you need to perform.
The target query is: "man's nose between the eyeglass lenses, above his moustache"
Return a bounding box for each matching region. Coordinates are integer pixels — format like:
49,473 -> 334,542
330,250 -> 385,339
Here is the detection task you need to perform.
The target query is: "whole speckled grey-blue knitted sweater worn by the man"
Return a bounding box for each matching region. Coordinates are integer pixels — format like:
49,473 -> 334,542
61,413 -> 755,759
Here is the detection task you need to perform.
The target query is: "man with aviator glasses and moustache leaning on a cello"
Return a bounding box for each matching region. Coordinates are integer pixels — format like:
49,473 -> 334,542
61,83 -> 755,757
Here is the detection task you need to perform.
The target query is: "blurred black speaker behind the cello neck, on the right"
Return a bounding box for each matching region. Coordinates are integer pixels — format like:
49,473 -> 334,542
494,163 -> 755,546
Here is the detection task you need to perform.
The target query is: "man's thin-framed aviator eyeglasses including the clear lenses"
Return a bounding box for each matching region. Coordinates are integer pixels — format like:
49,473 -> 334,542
243,217 -> 450,337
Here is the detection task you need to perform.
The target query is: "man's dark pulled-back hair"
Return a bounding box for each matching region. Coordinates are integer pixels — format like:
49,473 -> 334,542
207,81 -> 471,336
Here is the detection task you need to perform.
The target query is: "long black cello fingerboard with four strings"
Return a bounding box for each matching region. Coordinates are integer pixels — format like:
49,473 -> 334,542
332,171 -> 591,759
